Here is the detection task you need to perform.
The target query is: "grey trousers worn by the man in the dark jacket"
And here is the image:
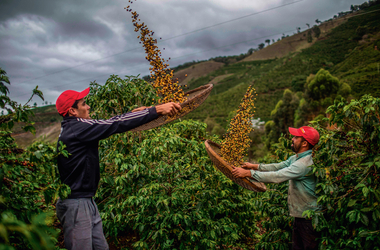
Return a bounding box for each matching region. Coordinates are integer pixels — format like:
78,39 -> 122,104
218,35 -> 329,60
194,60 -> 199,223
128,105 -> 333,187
56,198 -> 109,250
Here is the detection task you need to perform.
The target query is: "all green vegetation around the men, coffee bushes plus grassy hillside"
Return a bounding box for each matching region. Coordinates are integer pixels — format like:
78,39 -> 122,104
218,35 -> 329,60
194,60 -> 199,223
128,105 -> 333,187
0,1 -> 380,249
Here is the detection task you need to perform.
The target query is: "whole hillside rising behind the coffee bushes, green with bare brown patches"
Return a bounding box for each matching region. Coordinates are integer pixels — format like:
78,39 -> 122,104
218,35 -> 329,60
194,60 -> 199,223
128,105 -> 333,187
11,5 -> 380,145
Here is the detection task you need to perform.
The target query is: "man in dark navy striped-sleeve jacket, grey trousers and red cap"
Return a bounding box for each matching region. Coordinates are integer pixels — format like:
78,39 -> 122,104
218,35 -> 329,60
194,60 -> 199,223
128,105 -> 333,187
56,88 -> 181,250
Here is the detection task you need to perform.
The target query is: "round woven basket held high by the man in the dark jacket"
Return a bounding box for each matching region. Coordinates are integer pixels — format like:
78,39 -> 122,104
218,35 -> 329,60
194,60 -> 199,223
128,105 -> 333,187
130,83 -> 213,131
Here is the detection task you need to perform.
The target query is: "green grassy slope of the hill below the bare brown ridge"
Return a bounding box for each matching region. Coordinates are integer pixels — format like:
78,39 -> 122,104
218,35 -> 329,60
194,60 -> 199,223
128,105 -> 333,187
187,6 -> 380,127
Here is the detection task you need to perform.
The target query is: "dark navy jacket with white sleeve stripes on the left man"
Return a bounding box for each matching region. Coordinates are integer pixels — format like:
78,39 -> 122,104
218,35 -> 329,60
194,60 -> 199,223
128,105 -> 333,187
57,107 -> 158,198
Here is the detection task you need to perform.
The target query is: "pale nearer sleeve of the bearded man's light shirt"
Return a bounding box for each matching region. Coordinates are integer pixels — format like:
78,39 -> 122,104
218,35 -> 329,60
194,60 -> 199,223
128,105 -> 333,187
251,160 -> 307,183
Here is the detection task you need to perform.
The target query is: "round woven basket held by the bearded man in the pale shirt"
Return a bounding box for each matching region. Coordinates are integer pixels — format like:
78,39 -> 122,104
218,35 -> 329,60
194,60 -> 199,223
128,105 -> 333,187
205,140 -> 267,192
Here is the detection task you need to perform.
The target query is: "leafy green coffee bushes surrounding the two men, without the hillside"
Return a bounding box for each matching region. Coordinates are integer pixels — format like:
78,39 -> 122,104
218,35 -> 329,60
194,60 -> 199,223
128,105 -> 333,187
0,71 -> 380,249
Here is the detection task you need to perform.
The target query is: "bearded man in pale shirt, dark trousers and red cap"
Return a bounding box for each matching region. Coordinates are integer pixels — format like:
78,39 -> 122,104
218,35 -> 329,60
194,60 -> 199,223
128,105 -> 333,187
232,126 -> 319,250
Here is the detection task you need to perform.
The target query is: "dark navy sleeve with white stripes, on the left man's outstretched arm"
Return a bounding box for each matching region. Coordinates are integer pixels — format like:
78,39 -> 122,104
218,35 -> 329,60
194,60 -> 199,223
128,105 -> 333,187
72,107 -> 158,142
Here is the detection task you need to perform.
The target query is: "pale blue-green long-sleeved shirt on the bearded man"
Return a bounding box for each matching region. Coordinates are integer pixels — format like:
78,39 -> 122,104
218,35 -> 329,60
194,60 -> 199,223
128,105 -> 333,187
251,150 -> 319,218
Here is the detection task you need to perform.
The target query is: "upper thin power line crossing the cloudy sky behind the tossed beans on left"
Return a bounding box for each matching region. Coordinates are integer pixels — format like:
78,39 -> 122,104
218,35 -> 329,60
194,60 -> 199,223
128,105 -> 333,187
17,0 -> 304,84
